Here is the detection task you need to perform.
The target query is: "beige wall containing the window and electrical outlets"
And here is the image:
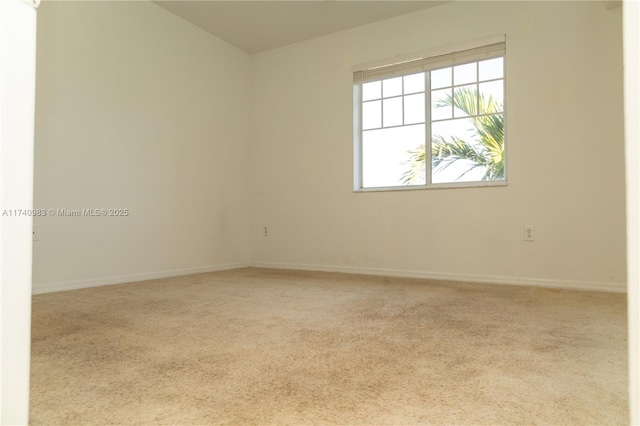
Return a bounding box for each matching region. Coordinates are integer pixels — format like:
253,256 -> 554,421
251,2 -> 625,291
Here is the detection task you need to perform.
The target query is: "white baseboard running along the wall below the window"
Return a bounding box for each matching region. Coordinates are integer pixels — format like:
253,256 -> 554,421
250,262 -> 627,293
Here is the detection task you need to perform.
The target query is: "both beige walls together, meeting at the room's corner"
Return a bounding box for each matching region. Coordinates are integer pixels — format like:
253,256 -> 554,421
34,2 -> 626,292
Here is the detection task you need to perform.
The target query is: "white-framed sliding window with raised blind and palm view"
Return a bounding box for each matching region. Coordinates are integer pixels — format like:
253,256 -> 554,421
354,42 -> 506,190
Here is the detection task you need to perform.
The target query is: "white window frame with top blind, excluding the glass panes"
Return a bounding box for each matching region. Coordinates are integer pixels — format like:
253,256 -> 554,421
353,35 -> 509,192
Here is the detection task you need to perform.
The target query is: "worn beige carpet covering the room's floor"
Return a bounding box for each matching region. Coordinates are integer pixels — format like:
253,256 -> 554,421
31,269 -> 629,425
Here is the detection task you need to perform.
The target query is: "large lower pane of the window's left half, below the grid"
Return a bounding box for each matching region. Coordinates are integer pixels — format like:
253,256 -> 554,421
362,124 -> 425,188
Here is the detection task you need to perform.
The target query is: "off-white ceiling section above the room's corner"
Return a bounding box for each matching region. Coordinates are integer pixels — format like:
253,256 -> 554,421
154,0 -> 447,54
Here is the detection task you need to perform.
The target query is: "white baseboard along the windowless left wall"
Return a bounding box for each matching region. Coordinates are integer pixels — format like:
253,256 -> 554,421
32,263 -> 250,294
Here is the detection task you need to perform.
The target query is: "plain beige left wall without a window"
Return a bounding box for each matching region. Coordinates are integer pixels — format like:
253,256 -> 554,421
33,2 -> 250,292
